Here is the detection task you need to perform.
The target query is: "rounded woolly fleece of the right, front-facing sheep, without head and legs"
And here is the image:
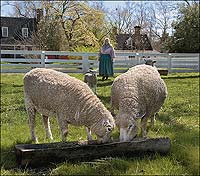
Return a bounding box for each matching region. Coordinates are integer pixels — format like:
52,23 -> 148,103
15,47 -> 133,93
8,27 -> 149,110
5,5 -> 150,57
111,64 -> 167,121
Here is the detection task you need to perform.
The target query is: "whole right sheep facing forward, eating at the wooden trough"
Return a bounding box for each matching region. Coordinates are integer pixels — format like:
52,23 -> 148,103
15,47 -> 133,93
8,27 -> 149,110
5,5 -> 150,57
111,64 -> 167,141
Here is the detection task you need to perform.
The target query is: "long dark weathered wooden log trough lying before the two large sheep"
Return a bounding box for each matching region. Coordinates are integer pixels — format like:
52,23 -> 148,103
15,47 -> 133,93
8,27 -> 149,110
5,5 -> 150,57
15,138 -> 171,167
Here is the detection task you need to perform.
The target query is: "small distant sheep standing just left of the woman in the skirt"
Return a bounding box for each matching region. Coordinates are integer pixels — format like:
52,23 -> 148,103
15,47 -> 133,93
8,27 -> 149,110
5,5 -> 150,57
84,70 -> 97,94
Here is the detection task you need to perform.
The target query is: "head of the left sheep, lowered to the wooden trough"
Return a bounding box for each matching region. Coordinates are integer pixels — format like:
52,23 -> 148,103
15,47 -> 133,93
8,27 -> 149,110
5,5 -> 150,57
91,119 -> 115,143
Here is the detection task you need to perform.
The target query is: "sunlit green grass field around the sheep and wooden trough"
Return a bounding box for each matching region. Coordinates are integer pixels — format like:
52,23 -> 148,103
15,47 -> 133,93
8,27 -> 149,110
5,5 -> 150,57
1,73 -> 199,175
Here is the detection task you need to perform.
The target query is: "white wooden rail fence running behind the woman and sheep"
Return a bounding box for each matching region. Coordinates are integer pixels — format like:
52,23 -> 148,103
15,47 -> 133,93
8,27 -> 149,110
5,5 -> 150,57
1,50 -> 200,73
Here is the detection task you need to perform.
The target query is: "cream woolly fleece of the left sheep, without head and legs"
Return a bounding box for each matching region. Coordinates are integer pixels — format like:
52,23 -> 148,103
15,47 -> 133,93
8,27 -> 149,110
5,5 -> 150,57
24,68 -> 114,141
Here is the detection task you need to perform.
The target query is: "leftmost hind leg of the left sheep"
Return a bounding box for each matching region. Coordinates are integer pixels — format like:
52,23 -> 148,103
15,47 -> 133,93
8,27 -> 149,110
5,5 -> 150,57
27,108 -> 38,143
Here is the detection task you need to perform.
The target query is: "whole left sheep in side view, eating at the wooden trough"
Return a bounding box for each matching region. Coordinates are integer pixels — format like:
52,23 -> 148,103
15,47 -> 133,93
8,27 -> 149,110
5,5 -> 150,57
24,68 -> 115,142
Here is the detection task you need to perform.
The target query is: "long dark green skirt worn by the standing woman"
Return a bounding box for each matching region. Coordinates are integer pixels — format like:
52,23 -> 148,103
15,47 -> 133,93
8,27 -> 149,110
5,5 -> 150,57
99,54 -> 114,76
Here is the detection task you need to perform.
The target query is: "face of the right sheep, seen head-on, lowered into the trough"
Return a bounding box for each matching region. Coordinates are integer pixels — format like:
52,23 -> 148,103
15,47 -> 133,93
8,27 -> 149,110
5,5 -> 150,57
116,114 -> 138,142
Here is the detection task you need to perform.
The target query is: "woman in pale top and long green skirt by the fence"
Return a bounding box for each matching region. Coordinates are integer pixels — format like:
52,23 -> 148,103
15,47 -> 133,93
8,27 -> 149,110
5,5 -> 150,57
99,38 -> 115,81
